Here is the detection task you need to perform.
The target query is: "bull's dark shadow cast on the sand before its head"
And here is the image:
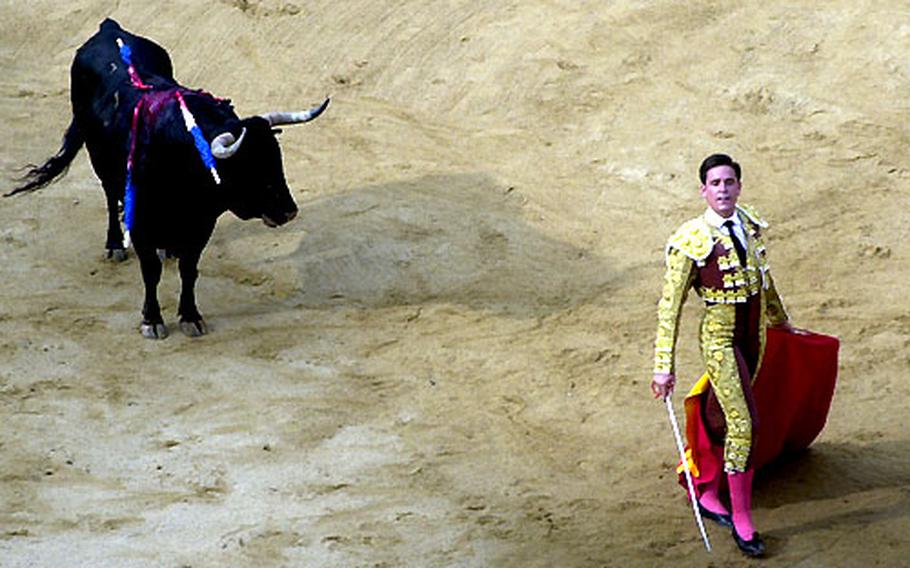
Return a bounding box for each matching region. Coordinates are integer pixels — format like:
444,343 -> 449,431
228,174 -> 609,317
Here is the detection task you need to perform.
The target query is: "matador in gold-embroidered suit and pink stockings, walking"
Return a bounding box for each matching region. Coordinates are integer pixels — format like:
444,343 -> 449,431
651,154 -> 790,556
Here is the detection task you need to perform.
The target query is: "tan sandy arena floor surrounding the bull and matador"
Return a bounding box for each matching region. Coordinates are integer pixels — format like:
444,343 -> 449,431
0,0 -> 910,568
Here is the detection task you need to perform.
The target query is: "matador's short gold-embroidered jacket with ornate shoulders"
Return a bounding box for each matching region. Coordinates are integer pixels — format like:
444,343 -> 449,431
654,205 -> 789,373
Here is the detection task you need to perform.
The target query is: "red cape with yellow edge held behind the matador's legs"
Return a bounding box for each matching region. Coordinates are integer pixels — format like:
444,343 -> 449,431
677,328 -> 840,490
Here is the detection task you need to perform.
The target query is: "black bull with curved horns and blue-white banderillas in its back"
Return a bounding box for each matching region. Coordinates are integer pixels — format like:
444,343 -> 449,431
6,19 -> 328,338
